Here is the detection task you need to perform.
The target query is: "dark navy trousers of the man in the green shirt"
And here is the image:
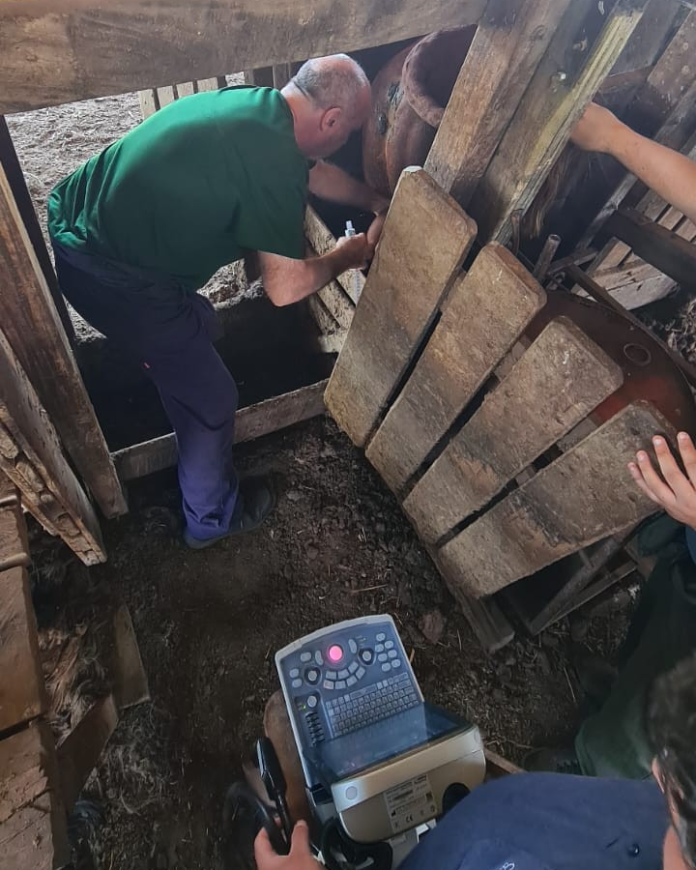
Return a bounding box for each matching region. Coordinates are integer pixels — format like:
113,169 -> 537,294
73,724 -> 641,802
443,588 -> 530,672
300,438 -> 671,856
54,242 -> 238,540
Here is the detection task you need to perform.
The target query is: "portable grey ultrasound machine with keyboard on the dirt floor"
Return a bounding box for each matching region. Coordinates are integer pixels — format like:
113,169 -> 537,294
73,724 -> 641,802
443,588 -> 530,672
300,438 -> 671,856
259,616 -> 485,870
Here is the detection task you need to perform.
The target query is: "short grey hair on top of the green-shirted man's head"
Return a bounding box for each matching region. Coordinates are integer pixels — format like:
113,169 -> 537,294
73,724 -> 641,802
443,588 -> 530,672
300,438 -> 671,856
291,54 -> 370,118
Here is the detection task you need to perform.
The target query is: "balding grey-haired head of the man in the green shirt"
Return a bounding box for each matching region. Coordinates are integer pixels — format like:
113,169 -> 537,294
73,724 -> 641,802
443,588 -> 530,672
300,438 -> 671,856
283,54 -> 371,157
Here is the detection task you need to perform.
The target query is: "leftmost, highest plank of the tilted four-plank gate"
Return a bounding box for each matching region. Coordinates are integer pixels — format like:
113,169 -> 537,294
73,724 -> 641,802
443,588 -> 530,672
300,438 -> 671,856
326,169 -> 476,446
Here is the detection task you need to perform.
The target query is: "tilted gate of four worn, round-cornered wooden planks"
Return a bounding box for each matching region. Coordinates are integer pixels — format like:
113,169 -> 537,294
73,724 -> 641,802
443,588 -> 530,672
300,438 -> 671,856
326,169 -> 672,648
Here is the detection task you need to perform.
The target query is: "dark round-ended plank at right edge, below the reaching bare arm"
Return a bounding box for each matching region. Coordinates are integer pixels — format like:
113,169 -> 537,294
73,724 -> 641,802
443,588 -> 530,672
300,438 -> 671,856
605,209 -> 696,289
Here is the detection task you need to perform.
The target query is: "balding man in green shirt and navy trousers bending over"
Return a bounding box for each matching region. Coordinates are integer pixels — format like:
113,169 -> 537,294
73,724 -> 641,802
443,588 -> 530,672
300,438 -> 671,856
48,55 -> 388,549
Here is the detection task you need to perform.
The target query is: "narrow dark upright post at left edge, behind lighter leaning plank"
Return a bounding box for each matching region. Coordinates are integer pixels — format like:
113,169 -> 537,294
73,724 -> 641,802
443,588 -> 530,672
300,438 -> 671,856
0,115 -> 75,343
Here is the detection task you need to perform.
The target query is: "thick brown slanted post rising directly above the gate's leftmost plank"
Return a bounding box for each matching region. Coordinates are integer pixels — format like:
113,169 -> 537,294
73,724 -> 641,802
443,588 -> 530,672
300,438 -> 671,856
424,0 -> 570,208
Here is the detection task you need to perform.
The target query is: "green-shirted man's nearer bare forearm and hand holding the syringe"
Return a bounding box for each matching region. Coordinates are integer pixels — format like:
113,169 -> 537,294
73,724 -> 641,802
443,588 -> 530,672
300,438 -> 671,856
259,233 -> 373,306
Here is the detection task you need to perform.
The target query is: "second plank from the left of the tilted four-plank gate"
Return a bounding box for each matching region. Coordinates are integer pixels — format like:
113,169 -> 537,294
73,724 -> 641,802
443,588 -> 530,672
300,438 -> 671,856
366,242 -> 546,491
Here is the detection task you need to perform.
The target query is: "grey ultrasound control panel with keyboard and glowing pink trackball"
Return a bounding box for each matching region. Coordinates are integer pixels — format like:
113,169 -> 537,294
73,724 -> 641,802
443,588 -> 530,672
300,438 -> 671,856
276,616 -> 423,779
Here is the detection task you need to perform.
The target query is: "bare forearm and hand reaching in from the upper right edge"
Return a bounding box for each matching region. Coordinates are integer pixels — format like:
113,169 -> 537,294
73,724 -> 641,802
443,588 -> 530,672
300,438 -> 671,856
570,103 -> 696,222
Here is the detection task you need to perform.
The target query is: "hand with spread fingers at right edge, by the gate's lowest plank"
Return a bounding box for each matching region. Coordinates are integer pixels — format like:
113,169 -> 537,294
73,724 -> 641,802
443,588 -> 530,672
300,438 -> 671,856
628,432 -> 696,529
